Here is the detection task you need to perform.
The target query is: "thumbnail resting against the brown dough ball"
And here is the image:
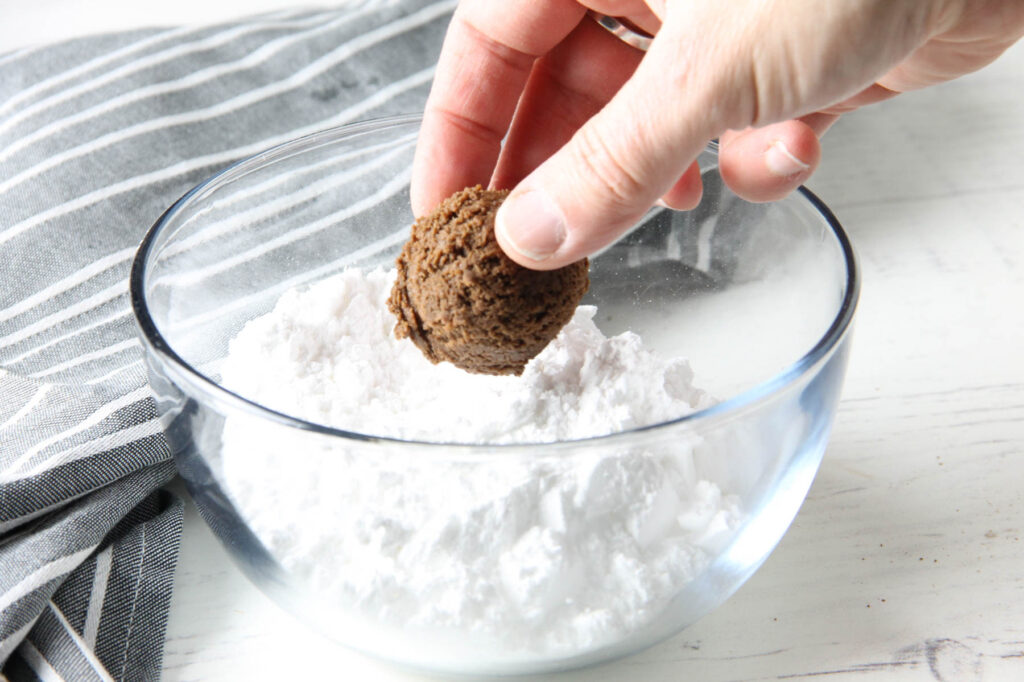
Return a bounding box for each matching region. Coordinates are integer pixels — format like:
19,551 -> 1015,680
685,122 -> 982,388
495,189 -> 565,260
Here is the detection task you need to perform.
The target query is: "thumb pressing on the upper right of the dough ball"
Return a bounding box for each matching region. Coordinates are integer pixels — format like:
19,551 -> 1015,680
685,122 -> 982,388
495,28 -> 715,270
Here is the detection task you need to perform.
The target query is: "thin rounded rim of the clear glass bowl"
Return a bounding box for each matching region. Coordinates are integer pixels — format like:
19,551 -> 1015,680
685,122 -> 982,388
128,114 -> 860,453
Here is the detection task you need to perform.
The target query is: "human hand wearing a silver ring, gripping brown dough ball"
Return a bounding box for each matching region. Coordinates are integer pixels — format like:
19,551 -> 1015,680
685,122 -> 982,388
412,0 -> 1024,269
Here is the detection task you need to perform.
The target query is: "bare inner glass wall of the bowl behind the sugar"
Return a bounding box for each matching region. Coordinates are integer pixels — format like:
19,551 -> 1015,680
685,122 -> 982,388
140,118 -> 855,419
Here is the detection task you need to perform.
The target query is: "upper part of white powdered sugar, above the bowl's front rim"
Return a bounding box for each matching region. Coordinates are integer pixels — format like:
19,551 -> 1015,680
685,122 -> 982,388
222,269 -> 710,442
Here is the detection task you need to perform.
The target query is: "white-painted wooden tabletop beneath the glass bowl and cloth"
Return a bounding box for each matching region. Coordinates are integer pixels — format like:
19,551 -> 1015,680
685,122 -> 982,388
6,0 -> 1024,682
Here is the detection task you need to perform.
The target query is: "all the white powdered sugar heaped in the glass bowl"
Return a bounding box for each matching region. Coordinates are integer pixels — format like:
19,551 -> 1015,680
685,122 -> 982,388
221,270 -> 740,655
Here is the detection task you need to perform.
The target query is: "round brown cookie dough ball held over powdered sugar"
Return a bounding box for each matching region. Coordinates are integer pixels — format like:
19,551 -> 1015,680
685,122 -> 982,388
388,185 -> 590,375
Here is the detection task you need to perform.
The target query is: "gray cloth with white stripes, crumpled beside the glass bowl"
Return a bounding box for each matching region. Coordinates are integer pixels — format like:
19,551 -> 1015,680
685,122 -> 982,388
0,0 -> 455,680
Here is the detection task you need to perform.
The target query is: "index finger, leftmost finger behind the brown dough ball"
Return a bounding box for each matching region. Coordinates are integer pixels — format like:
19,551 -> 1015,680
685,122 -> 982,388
411,0 -> 585,216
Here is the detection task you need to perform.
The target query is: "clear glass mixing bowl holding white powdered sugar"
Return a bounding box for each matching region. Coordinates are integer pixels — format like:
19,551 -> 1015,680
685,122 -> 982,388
131,112 -> 858,674
